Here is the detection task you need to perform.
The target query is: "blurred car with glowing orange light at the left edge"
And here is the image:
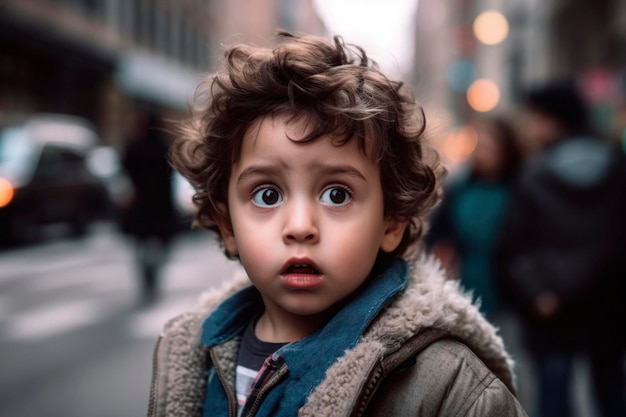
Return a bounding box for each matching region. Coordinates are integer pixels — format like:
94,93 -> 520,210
0,114 -> 114,243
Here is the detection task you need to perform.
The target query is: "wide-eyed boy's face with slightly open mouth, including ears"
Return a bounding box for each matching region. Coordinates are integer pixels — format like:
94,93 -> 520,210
220,116 -> 406,332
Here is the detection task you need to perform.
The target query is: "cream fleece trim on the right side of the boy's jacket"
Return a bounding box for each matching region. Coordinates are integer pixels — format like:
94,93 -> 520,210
298,256 -> 514,417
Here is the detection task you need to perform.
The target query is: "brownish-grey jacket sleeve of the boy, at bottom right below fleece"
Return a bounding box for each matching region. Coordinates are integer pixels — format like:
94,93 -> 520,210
366,339 -> 528,417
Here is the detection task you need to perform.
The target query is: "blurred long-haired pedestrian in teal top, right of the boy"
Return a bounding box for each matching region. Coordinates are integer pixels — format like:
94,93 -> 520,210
426,116 -> 522,320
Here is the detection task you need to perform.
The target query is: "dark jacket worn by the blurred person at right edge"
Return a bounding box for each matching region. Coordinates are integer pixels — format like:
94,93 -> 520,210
497,136 -> 626,350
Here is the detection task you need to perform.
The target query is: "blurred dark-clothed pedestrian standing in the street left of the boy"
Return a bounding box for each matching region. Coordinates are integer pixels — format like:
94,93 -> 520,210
123,112 -> 177,302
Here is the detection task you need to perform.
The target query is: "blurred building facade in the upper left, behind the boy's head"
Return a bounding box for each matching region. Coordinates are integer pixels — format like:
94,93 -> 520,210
0,0 -> 323,147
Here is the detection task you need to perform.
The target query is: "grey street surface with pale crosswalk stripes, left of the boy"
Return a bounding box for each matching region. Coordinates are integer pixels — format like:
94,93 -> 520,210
0,224 -> 236,417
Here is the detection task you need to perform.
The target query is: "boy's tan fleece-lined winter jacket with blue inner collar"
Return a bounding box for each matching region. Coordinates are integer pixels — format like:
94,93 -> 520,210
149,257 -> 526,417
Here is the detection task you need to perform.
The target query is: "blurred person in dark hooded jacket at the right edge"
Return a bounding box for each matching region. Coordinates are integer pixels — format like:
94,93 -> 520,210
498,81 -> 626,417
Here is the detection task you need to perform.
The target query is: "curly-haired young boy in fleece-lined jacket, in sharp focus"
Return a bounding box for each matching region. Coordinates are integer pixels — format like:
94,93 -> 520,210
149,33 -> 526,417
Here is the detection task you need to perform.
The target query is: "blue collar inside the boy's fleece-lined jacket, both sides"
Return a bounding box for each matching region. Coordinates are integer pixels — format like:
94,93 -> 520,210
201,260 -> 409,416
